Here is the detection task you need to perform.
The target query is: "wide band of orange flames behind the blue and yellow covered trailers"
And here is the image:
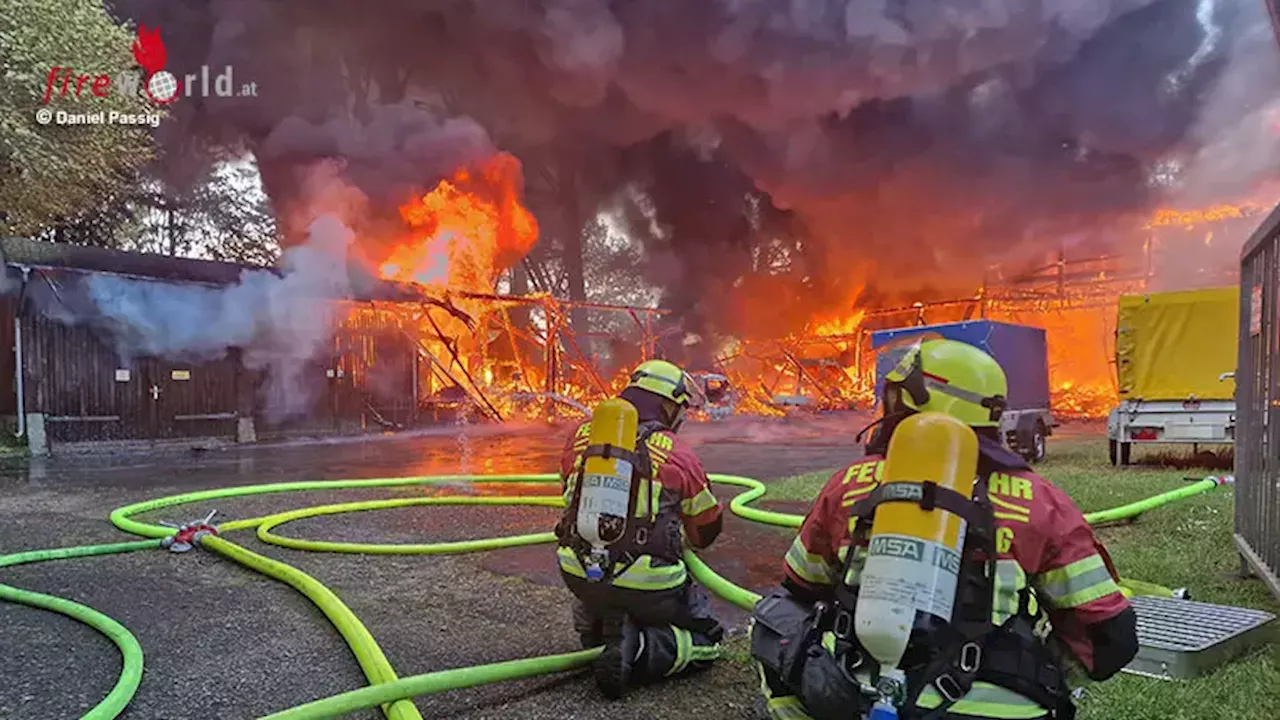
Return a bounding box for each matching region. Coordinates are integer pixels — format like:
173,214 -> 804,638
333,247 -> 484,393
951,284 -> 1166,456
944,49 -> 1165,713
719,202 -> 1263,418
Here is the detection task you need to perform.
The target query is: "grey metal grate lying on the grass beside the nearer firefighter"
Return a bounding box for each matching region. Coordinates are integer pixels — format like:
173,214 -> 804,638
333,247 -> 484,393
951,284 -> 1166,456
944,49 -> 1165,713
1125,596 -> 1275,679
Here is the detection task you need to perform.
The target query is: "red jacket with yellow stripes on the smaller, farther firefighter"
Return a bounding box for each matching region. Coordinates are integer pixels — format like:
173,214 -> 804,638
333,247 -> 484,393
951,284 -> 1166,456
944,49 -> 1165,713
557,423 -> 723,591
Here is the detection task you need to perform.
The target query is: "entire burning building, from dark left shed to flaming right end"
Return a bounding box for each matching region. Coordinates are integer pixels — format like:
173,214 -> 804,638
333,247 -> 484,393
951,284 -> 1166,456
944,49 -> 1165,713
0,176 -> 1258,452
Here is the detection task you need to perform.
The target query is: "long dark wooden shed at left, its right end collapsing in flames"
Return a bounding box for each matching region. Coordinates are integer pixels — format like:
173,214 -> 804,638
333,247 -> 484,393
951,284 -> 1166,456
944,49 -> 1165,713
0,155 -> 660,454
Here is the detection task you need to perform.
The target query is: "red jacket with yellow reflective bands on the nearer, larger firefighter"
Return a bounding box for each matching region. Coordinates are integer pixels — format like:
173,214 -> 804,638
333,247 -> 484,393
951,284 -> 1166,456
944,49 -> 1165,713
785,455 -> 1129,717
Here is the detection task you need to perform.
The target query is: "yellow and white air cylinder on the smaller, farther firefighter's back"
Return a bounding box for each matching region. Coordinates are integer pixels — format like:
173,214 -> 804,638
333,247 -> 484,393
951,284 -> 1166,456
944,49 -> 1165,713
577,398 -> 639,580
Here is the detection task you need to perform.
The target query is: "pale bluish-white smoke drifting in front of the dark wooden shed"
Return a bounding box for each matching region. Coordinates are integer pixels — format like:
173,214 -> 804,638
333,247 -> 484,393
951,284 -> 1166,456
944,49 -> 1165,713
86,214 -> 355,420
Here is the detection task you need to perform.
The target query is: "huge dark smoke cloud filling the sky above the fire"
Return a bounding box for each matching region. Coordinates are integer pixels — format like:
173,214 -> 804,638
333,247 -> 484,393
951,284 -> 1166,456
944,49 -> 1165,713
116,0 -> 1277,338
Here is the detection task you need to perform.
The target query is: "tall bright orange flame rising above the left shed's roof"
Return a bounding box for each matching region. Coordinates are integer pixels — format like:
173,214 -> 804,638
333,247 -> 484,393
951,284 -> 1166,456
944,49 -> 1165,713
380,154 -> 538,292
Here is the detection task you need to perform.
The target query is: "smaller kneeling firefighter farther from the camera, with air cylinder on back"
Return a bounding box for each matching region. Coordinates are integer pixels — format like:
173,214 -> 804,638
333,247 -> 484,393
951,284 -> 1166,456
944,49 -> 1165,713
556,360 -> 724,698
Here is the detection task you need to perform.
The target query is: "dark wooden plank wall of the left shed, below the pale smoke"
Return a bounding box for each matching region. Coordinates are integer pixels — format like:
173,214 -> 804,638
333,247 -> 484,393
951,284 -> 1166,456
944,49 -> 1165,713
0,278 -> 429,442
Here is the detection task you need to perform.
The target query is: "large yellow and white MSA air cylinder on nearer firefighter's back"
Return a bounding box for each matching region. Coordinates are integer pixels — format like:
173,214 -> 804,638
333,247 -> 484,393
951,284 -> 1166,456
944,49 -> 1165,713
854,413 -> 978,670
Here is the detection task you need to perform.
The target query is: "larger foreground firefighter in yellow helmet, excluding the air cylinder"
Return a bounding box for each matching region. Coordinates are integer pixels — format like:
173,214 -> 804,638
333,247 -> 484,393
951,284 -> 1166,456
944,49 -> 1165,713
753,340 -> 1138,720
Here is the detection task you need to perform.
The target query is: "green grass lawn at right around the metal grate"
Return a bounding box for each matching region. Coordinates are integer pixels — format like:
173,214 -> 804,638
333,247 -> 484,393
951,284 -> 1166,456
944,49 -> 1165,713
765,437 -> 1280,720
